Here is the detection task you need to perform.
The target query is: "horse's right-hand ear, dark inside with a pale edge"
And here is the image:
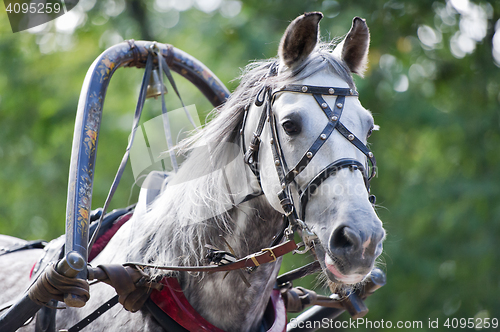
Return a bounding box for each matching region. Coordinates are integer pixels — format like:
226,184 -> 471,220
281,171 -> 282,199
333,17 -> 370,76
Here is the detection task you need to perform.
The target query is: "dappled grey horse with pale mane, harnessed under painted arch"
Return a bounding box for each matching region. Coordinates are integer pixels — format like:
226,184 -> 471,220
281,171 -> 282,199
0,13 -> 385,331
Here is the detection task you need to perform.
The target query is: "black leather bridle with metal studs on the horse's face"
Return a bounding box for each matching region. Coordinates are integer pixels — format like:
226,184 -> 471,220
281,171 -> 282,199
240,68 -> 376,246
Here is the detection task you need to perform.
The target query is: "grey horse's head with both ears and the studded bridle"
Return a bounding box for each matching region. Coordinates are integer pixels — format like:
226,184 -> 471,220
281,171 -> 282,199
245,13 -> 385,284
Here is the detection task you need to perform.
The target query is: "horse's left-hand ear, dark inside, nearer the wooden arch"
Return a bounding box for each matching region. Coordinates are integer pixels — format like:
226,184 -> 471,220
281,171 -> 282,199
278,12 -> 323,68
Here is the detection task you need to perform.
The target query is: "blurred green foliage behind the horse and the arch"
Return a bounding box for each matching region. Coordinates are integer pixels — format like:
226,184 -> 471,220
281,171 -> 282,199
0,0 -> 500,329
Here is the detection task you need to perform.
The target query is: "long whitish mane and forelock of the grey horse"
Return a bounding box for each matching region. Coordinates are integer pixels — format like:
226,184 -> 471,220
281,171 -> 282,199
122,43 -> 354,275
